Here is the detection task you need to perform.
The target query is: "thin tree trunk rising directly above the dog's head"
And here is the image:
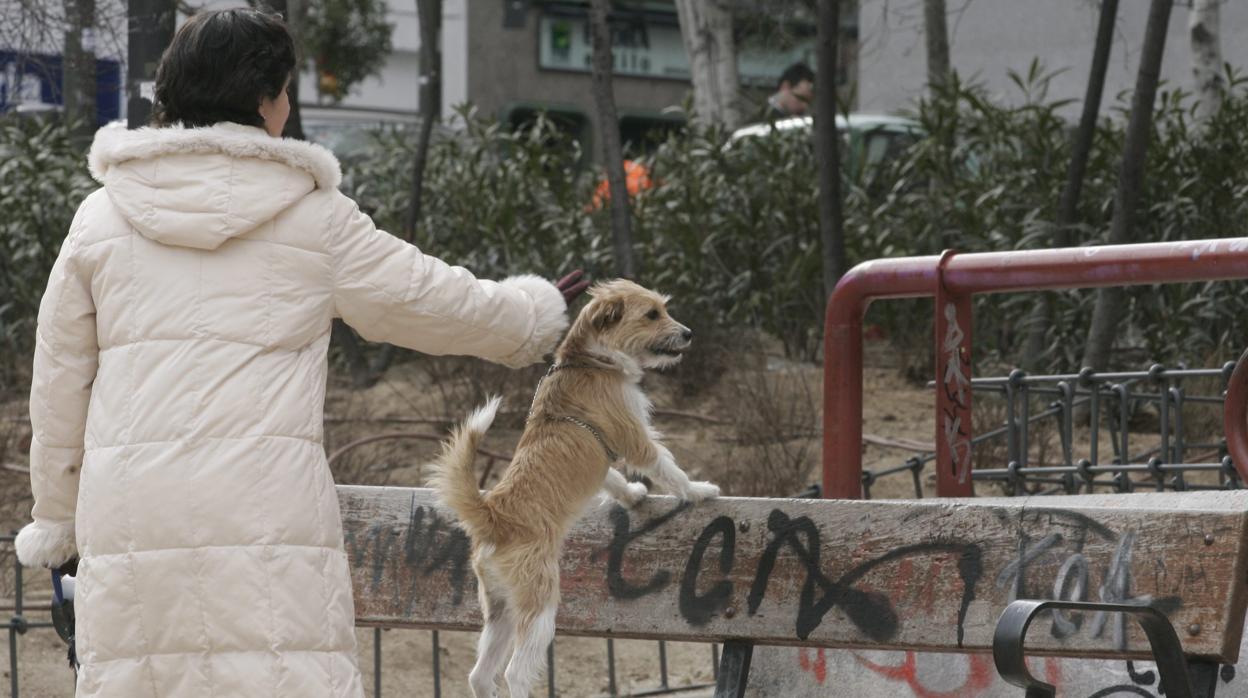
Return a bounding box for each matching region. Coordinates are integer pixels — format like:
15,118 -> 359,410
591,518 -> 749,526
589,0 -> 638,278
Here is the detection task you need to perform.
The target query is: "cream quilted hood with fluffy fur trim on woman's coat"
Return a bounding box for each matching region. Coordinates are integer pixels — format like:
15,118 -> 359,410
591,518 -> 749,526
87,122 -> 342,250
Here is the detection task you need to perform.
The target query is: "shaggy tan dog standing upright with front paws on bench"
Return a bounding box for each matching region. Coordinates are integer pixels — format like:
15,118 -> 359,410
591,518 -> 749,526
433,280 -> 719,698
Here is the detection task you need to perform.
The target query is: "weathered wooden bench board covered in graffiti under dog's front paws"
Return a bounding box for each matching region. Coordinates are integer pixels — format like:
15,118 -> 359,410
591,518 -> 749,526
338,487 -> 1248,663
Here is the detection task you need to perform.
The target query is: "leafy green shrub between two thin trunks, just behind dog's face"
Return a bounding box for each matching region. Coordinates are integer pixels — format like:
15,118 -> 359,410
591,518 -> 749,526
633,121 -> 824,357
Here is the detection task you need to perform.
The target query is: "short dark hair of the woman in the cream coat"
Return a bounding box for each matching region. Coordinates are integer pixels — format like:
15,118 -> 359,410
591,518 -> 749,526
152,9 -> 295,126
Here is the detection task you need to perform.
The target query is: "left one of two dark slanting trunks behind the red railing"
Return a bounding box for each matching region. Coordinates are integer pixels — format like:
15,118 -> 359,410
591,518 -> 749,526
1022,0 -> 1118,371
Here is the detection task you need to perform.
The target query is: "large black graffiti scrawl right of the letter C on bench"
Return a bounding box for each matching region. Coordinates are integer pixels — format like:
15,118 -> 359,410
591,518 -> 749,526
748,509 -> 983,647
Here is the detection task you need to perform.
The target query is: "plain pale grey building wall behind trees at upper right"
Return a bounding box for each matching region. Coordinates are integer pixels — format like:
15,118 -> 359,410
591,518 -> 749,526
857,0 -> 1248,119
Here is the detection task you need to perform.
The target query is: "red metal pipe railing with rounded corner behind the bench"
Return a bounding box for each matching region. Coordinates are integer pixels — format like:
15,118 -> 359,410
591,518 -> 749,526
822,237 -> 1248,499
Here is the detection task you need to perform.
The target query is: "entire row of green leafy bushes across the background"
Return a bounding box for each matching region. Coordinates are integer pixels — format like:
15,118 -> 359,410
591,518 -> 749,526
7,65 -> 1248,375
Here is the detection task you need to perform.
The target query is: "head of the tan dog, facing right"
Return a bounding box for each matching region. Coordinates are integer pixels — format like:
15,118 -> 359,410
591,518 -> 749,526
570,278 -> 694,368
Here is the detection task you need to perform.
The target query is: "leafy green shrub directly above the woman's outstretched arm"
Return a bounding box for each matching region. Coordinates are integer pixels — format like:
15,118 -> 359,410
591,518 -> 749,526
346,111 -> 610,277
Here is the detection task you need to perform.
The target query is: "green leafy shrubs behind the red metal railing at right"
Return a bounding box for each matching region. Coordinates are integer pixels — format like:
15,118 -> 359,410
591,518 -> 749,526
873,65 -> 1248,370
